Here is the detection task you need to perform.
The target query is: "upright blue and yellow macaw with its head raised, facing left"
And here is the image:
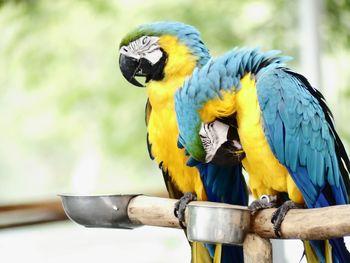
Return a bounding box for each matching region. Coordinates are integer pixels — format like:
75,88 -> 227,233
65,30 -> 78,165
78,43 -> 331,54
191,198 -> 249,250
119,22 -> 248,262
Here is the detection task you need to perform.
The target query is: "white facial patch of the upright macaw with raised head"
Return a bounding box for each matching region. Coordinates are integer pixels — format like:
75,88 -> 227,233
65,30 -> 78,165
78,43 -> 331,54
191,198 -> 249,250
120,36 -> 163,65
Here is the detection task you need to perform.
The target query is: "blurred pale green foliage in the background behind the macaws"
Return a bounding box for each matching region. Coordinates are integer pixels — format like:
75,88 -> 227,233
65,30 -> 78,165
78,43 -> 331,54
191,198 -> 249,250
0,0 -> 349,202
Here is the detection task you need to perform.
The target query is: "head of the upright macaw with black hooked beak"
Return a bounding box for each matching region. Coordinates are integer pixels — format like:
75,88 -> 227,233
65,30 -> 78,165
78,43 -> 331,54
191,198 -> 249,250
119,22 -> 210,87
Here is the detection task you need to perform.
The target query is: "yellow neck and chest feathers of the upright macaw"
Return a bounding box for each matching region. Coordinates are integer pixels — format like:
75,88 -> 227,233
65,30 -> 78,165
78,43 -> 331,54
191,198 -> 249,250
147,36 -> 206,200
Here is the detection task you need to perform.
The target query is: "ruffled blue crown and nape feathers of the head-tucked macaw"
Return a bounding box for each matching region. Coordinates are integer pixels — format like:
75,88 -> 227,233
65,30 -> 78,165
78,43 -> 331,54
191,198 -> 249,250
175,49 -> 290,161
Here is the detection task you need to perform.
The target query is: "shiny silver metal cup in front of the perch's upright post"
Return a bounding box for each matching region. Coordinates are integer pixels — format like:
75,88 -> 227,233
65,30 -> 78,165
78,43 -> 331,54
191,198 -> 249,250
187,202 -> 250,245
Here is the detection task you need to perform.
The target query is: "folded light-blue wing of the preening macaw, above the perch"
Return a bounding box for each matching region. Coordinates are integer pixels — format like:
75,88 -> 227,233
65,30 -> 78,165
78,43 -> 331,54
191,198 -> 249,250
257,68 -> 348,207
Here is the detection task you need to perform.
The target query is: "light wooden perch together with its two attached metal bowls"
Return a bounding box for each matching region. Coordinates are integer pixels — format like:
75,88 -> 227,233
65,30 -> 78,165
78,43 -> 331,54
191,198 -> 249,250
61,195 -> 350,263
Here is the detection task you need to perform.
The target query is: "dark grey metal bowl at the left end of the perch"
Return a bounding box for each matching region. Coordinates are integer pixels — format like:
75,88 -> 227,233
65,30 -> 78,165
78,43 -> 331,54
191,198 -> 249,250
60,195 -> 139,229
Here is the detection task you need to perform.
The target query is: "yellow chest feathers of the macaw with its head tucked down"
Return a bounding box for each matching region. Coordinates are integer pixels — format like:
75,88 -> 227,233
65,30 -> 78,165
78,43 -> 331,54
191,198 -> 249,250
235,75 -> 303,203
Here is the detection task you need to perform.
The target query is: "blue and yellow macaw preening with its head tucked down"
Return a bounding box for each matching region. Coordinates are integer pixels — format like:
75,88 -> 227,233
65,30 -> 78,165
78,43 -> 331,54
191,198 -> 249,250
175,49 -> 350,262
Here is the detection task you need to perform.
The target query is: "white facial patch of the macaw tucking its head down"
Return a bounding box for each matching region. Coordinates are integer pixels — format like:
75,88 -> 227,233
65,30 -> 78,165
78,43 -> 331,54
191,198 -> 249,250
199,121 -> 229,163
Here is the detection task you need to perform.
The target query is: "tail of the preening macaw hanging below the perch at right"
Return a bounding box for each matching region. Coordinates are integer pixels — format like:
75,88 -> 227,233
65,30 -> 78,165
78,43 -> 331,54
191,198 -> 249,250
303,238 -> 350,263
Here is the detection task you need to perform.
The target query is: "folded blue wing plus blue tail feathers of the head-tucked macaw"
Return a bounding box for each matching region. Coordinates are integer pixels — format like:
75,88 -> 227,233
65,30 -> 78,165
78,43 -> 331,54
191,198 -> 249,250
257,68 -> 350,262
